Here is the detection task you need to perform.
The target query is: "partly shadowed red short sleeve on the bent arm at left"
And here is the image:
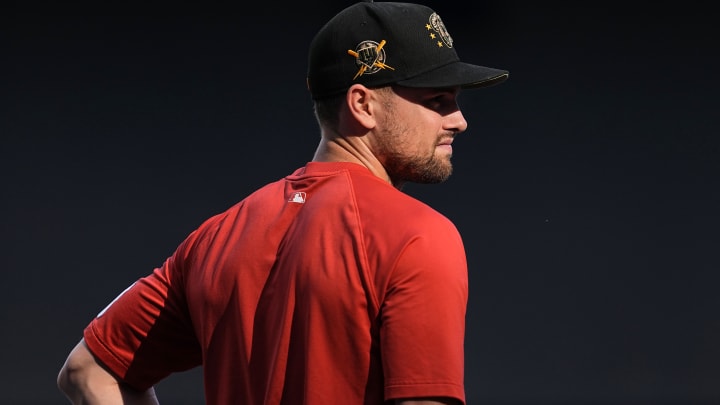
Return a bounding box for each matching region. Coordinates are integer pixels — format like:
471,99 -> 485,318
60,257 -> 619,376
84,235 -> 202,390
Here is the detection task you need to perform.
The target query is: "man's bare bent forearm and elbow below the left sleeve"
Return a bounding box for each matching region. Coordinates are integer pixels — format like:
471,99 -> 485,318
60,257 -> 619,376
57,341 -> 158,405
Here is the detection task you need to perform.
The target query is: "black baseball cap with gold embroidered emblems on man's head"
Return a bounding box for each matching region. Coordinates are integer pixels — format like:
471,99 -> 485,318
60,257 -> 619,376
307,1 -> 509,100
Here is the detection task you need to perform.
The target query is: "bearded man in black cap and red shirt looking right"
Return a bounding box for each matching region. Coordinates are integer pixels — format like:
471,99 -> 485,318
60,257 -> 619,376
58,2 -> 508,405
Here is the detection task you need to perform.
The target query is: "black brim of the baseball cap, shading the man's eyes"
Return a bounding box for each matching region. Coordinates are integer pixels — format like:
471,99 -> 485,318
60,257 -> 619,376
397,62 -> 509,89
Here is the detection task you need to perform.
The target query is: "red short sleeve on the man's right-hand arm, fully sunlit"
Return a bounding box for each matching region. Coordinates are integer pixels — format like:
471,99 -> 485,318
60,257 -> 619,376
380,222 -> 468,401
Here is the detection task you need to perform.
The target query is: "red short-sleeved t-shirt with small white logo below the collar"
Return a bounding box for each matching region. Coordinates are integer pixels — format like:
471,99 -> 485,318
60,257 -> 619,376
84,162 -> 467,404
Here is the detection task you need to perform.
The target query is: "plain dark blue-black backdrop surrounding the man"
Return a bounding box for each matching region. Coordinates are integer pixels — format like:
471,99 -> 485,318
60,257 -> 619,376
0,0 -> 720,405
